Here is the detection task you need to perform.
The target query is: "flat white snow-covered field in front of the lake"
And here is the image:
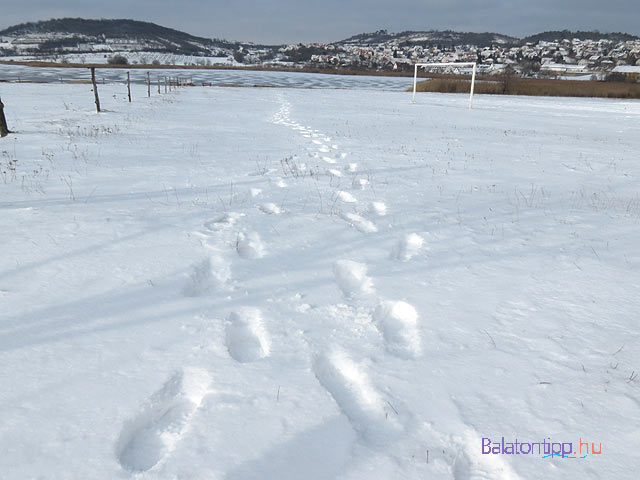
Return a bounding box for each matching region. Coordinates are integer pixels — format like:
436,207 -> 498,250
0,80 -> 640,480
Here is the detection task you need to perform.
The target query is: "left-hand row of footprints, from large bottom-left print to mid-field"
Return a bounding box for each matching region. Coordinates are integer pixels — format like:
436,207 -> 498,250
116,206 -> 274,473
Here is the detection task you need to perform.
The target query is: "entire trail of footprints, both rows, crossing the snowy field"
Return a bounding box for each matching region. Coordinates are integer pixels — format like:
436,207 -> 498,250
116,97 -> 500,479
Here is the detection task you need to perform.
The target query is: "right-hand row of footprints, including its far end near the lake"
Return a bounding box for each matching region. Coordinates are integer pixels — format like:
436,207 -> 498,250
274,96 -> 422,445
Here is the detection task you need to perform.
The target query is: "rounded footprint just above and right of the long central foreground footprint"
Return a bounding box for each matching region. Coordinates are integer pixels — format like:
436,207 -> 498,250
373,301 -> 422,358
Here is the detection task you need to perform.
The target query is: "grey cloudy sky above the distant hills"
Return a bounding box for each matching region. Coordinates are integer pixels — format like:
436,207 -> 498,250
0,0 -> 640,43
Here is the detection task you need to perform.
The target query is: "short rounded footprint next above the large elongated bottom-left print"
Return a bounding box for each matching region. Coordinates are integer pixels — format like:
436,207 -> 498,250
225,307 -> 270,363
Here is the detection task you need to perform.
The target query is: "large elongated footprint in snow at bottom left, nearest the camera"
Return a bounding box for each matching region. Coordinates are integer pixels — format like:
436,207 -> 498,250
116,368 -> 211,472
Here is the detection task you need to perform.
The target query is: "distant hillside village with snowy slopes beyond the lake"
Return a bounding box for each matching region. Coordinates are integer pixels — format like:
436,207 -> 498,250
0,24 -> 640,76
